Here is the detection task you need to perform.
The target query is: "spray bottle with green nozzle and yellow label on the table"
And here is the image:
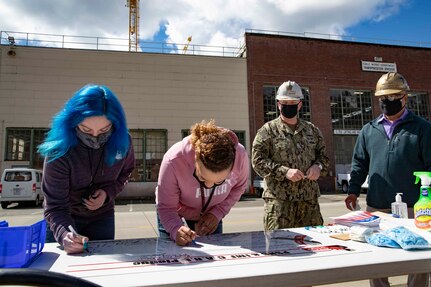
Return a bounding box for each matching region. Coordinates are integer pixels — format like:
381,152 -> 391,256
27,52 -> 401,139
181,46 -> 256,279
413,171 -> 431,230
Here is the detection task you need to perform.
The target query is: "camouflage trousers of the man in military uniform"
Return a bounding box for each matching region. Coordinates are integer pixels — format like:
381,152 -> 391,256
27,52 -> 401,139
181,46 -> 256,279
263,198 -> 323,230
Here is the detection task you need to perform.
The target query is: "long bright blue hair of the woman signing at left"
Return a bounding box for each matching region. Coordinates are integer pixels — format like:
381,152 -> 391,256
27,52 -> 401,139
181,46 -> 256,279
38,84 -> 130,166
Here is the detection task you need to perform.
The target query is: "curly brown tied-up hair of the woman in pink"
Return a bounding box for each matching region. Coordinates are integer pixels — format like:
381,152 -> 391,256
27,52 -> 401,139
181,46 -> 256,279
190,120 -> 235,172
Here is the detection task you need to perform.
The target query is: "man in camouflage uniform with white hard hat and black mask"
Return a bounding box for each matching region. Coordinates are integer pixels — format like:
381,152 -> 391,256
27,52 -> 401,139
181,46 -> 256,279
252,81 -> 329,230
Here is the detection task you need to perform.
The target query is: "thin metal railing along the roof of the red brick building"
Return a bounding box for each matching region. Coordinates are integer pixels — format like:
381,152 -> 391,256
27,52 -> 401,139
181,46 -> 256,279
245,29 -> 431,48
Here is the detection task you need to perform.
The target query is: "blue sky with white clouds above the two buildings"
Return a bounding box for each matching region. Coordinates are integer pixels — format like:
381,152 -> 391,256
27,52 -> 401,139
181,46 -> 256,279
0,0 -> 431,48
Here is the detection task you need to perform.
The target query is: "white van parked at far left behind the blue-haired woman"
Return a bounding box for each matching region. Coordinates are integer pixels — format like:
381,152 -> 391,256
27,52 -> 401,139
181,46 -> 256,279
0,168 -> 43,209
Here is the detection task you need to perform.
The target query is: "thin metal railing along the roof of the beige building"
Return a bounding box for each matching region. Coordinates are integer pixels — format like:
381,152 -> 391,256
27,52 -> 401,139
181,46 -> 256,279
0,31 -> 245,57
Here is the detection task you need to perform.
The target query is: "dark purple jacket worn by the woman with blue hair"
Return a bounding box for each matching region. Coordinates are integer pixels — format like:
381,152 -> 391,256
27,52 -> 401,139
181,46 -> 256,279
42,139 -> 135,242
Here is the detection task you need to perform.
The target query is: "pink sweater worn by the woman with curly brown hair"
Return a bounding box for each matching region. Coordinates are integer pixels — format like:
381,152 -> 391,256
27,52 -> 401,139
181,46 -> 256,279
156,132 -> 250,240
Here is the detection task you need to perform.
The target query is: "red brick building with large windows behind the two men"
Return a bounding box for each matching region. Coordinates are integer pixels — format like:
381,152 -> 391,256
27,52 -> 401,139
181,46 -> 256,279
245,33 -> 431,191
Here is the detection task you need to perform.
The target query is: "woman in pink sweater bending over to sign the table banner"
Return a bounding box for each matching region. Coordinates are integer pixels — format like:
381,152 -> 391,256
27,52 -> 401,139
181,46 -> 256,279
156,120 -> 250,246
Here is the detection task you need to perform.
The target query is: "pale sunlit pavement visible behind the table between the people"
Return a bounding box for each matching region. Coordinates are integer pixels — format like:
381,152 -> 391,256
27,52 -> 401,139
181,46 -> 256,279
0,194 -> 347,236
